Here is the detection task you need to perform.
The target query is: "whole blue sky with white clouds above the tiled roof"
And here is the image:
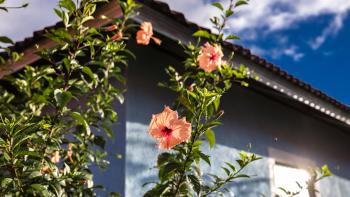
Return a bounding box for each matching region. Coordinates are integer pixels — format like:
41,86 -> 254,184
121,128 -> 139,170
0,0 -> 350,105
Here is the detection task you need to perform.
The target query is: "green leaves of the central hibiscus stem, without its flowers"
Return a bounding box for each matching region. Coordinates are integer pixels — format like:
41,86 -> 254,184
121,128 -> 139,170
145,1 -> 260,196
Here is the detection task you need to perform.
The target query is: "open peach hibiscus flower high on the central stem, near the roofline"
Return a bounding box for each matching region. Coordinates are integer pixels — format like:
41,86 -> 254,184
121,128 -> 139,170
197,42 -> 224,73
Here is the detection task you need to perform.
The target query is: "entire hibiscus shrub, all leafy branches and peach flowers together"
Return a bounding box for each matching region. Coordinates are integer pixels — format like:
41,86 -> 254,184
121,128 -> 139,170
0,0 -> 331,197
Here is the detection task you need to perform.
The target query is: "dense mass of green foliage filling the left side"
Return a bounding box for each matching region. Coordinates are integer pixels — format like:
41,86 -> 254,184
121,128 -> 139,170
0,0 -> 139,196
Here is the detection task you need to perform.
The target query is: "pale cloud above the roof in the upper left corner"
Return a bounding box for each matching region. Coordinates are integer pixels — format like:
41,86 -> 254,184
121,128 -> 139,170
0,0 -> 59,41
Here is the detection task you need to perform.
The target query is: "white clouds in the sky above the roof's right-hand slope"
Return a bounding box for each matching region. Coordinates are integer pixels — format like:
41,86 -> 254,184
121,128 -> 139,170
163,0 -> 350,48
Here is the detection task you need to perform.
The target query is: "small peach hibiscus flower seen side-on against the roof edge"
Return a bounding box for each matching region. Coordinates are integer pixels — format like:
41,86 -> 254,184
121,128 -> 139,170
136,22 -> 161,45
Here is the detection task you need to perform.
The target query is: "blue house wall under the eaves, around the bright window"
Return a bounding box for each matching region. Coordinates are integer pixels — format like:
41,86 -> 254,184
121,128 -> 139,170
125,42 -> 350,197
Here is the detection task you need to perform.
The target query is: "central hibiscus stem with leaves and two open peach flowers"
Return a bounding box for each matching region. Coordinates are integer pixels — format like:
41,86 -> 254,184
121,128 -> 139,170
145,0 -> 330,197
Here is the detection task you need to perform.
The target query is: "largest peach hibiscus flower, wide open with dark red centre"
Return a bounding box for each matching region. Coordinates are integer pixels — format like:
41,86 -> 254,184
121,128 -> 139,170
149,106 -> 191,149
